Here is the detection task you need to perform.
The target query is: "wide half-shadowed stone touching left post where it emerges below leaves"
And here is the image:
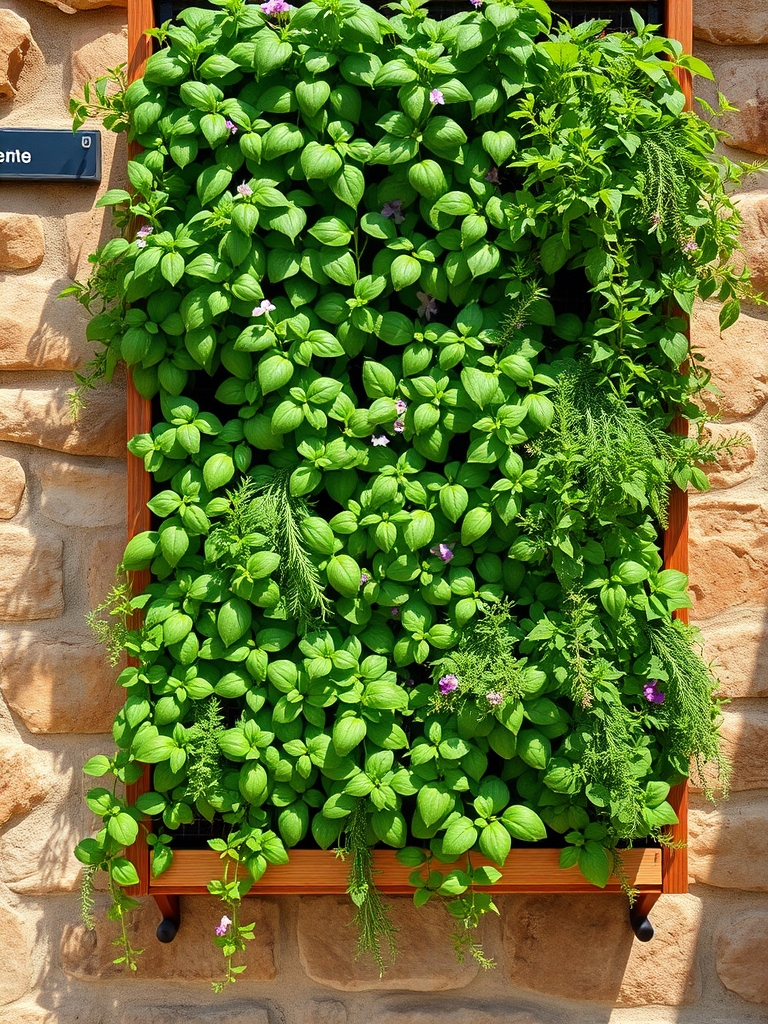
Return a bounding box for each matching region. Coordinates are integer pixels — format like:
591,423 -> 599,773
0,382 -> 125,458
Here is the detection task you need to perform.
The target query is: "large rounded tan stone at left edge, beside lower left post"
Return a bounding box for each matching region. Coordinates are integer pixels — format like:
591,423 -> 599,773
0,632 -> 125,733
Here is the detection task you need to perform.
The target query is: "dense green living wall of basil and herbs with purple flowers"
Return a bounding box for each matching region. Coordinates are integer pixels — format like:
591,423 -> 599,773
71,0 -> 748,981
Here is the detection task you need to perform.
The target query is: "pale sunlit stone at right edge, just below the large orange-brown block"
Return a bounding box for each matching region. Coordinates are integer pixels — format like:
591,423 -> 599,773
703,608 -> 768,698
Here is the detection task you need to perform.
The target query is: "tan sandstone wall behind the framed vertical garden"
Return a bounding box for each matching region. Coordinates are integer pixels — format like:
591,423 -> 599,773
0,0 -> 768,1024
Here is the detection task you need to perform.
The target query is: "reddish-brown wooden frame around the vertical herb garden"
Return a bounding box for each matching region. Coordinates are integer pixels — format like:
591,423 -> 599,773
127,0 -> 693,942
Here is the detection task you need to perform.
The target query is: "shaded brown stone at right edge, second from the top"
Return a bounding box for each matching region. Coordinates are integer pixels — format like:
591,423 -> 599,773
718,59 -> 768,154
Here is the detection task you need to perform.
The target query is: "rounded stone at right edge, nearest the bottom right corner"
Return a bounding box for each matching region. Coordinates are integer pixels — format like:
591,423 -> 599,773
716,912 -> 768,1002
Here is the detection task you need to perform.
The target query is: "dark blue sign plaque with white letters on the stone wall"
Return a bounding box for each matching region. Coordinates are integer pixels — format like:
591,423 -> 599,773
0,128 -> 101,184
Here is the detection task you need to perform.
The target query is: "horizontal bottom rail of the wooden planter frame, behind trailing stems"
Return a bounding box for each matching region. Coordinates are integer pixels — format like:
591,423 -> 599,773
148,849 -> 662,896
